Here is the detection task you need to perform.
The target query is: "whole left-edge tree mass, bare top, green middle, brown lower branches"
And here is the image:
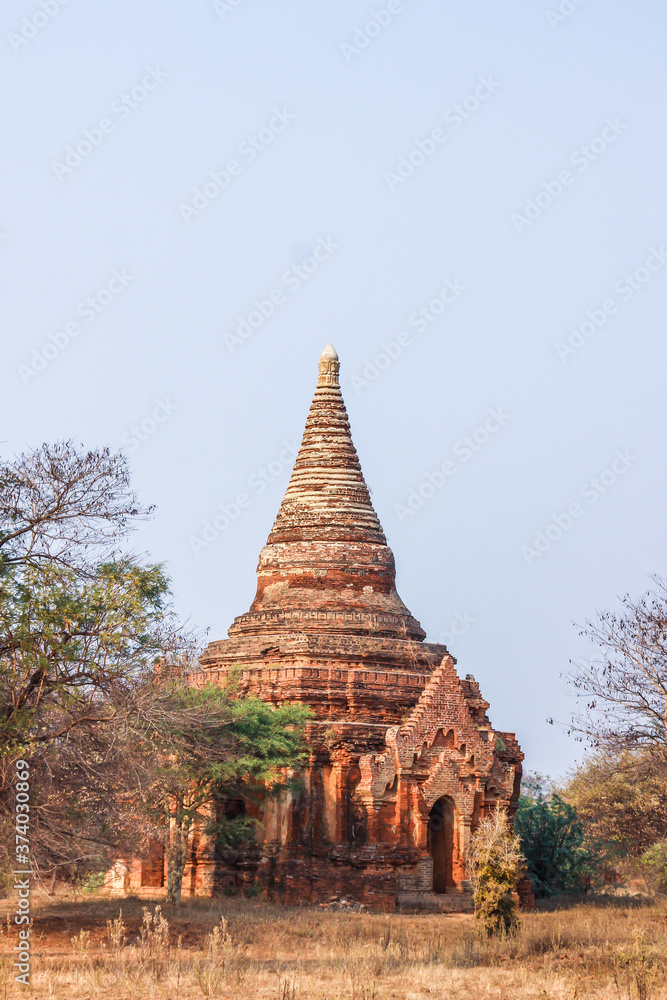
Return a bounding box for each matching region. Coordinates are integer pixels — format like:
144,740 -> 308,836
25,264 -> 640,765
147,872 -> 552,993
0,442 -> 183,884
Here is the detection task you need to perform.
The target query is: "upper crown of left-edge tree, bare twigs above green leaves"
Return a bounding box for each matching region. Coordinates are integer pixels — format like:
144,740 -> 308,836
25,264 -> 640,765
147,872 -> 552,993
0,442 -> 175,761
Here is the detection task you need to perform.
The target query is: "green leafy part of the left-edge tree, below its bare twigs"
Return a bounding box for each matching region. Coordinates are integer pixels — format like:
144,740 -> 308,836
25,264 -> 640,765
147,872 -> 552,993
0,558 -> 169,756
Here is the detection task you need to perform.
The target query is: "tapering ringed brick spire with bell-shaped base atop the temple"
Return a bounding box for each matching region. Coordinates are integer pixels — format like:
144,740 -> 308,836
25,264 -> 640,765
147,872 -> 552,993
229,344 -> 425,640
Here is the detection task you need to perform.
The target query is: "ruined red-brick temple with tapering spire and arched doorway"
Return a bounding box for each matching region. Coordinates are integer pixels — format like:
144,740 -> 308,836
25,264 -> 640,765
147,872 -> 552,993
112,345 -> 523,910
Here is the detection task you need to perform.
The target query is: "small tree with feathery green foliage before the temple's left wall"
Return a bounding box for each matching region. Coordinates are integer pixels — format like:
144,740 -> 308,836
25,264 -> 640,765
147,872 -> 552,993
138,676 -> 310,902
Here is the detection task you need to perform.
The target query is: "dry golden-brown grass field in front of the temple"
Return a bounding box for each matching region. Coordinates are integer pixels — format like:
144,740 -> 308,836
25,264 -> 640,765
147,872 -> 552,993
0,896 -> 667,1000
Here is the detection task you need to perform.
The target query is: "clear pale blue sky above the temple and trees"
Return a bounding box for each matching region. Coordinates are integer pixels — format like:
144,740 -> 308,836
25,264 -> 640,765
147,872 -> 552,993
0,0 -> 667,775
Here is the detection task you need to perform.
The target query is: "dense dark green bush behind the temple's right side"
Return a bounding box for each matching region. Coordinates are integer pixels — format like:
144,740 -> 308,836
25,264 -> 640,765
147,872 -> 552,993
514,782 -> 606,897
